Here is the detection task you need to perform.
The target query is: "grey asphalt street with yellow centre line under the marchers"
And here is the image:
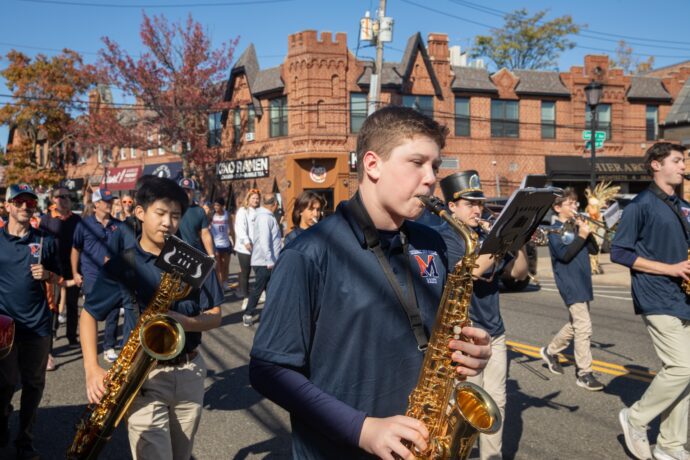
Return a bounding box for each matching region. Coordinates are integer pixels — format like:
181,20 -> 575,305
0,255 -> 684,459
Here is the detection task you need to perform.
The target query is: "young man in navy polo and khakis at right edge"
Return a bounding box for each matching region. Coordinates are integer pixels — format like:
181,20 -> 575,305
611,142 -> 690,460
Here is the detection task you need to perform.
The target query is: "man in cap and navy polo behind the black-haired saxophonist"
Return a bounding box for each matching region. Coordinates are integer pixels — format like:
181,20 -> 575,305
71,189 -> 124,362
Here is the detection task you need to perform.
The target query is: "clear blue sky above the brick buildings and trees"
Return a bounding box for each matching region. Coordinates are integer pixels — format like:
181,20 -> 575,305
0,0 -> 690,145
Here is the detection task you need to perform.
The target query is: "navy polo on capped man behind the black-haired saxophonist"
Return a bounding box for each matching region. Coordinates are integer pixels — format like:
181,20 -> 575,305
72,215 -> 122,292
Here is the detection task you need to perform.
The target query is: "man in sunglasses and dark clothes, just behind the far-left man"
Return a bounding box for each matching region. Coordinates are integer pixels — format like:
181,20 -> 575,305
39,187 -> 81,346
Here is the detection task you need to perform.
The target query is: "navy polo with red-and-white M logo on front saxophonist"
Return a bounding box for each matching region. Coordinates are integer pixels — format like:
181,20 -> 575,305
251,203 -> 447,459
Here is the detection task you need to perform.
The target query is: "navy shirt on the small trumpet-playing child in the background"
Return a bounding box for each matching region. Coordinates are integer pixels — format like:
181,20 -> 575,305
549,220 -> 594,306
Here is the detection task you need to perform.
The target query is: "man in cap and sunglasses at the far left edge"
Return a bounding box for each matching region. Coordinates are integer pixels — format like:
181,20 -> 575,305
0,184 -> 59,459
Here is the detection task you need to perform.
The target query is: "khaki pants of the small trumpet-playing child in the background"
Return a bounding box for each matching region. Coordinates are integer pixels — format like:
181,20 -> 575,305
546,302 -> 592,376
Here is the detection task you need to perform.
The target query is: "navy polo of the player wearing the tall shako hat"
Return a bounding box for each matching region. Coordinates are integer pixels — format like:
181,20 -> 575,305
439,224 -> 512,337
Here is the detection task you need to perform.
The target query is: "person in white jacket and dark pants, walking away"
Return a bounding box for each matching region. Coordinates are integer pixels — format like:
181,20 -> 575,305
242,193 -> 283,326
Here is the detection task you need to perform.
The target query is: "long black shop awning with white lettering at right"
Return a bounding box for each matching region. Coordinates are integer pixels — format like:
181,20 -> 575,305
545,156 -> 651,182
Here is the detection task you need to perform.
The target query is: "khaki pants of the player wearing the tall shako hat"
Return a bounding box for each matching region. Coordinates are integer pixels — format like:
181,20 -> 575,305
467,334 -> 508,460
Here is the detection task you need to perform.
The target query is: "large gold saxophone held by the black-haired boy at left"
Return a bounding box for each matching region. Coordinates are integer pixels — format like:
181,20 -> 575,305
67,272 -> 190,459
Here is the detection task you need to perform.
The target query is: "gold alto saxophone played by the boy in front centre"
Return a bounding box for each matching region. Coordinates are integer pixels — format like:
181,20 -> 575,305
406,196 -> 502,459
